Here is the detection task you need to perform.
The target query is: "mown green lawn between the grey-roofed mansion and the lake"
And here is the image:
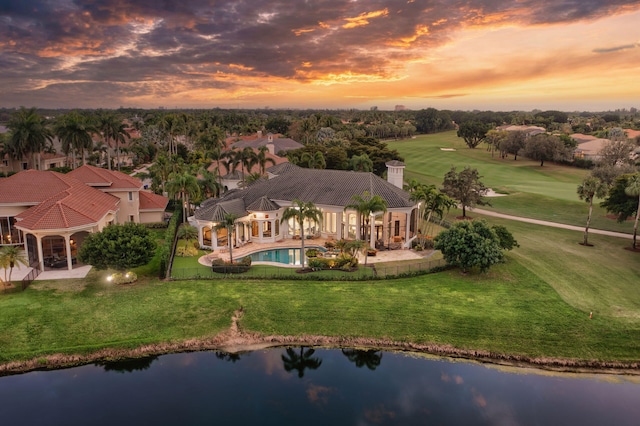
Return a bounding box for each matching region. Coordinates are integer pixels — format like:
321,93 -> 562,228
0,246 -> 640,361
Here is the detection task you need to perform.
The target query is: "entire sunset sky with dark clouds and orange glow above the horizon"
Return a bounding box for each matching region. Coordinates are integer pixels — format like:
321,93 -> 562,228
0,0 -> 640,111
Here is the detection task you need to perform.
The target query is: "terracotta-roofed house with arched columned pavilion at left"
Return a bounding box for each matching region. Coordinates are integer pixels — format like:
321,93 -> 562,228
0,166 -> 168,270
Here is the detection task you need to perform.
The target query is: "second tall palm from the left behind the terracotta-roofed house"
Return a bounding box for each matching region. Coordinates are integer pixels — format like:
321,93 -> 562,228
53,111 -> 98,169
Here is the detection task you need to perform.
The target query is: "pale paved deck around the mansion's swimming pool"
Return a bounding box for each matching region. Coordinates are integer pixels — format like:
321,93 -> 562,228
198,238 -> 424,267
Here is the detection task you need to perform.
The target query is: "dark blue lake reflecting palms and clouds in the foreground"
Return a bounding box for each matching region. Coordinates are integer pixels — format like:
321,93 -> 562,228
0,347 -> 640,426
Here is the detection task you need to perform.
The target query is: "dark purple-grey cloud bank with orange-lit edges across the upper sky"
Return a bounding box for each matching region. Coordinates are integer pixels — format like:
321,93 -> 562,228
0,0 -> 639,105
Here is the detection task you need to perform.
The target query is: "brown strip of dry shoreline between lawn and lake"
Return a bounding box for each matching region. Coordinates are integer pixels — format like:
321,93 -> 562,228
0,311 -> 640,377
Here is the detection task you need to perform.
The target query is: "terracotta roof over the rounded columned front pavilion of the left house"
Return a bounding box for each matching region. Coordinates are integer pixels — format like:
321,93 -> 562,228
16,176 -> 120,230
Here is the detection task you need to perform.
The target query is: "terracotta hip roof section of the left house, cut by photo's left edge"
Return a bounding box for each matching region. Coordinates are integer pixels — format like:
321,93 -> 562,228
0,170 -> 77,205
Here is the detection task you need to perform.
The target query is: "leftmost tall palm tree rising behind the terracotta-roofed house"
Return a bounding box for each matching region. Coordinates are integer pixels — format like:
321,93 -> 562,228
7,107 -> 53,169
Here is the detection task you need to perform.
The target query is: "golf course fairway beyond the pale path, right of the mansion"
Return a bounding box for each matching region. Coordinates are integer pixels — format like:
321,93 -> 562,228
389,132 -> 633,233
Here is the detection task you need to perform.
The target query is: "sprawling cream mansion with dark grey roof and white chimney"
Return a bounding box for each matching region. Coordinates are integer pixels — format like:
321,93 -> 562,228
189,161 -> 417,250
